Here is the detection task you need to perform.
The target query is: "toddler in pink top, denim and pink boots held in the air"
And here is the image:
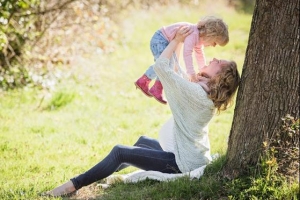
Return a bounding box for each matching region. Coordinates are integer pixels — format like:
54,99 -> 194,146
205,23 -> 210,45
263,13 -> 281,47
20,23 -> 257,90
135,16 -> 229,104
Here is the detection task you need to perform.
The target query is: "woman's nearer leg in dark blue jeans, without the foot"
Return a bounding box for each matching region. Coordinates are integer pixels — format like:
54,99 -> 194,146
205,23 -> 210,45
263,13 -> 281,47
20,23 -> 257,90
71,141 -> 180,190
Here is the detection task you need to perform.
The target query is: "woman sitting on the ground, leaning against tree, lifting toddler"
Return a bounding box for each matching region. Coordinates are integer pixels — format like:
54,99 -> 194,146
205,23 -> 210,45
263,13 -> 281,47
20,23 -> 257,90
46,27 -> 240,197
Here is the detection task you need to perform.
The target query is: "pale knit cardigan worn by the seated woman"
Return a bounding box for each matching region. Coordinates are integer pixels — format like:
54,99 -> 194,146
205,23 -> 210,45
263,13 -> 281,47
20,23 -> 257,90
154,58 -> 215,173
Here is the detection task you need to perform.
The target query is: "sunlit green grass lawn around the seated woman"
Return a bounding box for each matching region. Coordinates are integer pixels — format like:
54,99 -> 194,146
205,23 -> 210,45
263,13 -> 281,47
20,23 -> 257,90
0,1 -> 251,200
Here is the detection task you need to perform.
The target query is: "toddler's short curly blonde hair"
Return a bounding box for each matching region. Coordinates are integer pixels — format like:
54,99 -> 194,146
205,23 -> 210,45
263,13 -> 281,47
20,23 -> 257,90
197,16 -> 229,46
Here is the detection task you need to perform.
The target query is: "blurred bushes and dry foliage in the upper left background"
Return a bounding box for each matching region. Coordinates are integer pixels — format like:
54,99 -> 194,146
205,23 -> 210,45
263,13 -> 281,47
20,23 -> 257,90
0,0 -> 250,90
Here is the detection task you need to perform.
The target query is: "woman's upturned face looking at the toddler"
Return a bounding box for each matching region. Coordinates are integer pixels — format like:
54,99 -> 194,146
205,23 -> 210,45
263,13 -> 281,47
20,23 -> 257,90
199,58 -> 229,78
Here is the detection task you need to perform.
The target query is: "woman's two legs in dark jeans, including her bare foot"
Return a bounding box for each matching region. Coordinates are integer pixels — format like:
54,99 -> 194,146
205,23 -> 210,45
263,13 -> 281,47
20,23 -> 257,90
47,136 -> 180,196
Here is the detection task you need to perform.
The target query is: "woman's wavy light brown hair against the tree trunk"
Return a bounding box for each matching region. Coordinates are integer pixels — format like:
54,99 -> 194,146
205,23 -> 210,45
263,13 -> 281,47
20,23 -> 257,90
207,61 -> 240,112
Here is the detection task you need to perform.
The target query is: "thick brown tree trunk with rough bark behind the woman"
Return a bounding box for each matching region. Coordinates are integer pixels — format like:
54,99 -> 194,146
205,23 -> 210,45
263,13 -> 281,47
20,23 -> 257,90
223,0 -> 300,178
